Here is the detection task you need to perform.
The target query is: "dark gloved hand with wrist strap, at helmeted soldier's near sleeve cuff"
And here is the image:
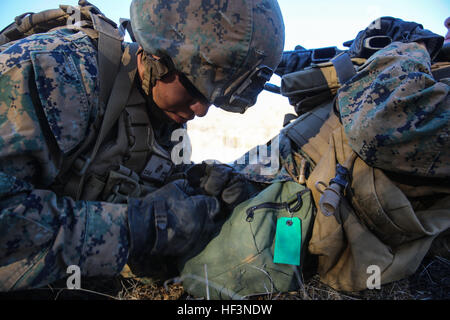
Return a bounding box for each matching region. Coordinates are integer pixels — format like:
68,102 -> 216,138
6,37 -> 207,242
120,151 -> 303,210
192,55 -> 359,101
128,180 -> 220,261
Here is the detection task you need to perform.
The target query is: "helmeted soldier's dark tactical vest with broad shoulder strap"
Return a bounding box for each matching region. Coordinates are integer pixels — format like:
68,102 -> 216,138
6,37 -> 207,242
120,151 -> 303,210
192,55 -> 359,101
0,0 -> 179,203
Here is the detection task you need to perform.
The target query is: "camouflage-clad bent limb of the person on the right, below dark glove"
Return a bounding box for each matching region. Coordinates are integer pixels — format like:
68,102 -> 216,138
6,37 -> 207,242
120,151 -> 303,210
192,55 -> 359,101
338,42 -> 450,178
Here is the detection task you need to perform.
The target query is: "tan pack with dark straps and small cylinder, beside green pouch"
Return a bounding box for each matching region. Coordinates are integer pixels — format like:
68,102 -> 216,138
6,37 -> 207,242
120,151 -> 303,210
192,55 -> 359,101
280,42 -> 450,291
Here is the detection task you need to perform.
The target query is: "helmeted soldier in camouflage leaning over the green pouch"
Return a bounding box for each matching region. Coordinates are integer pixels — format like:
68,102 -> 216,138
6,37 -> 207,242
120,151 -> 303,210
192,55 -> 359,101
0,0 -> 284,291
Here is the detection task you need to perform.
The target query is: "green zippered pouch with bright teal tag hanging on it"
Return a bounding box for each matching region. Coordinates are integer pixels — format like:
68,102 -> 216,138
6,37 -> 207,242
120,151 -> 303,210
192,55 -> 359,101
180,181 -> 314,300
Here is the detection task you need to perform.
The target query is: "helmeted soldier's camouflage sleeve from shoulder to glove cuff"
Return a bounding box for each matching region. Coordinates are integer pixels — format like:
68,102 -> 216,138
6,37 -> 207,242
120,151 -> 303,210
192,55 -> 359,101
0,29 -> 129,291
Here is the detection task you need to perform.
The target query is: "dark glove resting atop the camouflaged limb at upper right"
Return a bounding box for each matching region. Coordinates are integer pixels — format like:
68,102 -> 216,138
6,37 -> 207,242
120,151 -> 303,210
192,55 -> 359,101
349,17 -> 444,60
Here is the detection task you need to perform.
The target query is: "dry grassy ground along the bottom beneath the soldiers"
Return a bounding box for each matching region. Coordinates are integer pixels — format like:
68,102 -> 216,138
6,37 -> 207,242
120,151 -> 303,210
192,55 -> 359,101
0,257 -> 450,300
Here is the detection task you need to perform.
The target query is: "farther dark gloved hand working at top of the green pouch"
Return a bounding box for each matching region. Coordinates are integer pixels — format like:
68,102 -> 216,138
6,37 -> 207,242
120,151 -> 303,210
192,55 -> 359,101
187,163 -> 259,211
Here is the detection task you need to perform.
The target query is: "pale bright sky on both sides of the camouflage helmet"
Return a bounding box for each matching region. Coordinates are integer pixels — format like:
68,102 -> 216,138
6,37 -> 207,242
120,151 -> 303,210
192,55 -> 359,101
0,0 -> 450,50
